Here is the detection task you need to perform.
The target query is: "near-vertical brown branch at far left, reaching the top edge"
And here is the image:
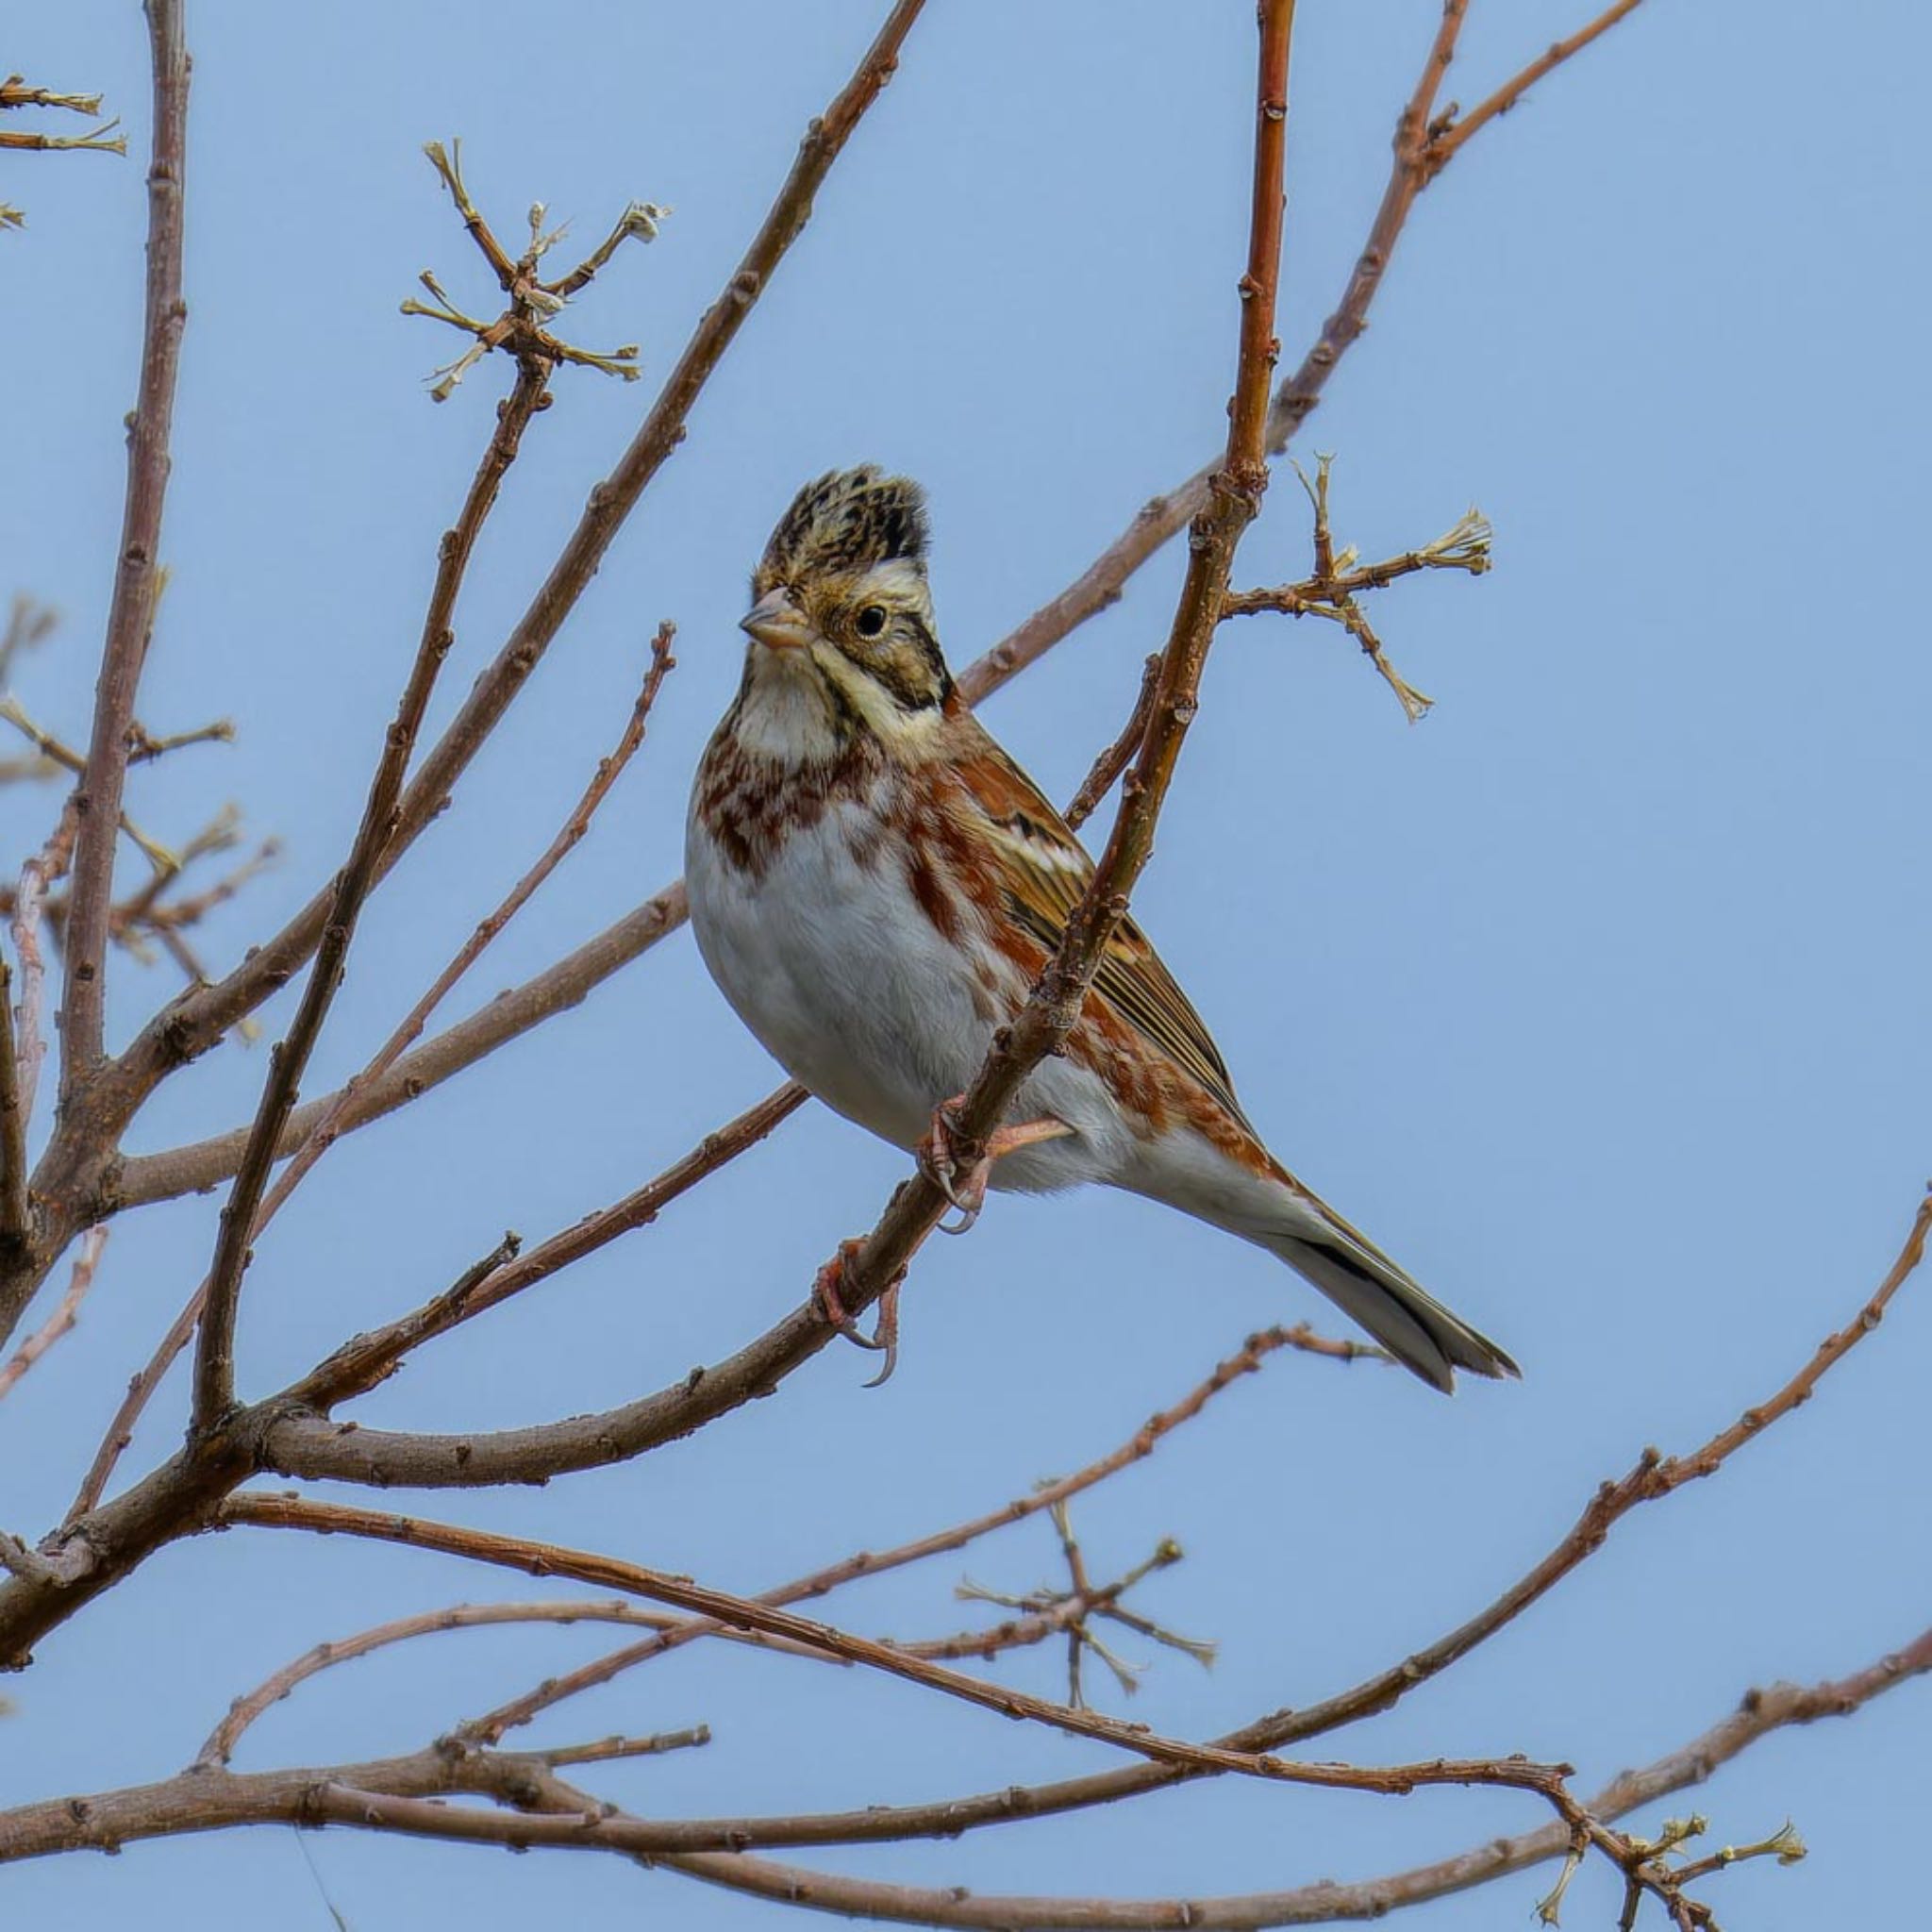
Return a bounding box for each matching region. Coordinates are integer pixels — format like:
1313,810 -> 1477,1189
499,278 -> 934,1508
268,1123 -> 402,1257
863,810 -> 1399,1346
55,0 -> 190,1090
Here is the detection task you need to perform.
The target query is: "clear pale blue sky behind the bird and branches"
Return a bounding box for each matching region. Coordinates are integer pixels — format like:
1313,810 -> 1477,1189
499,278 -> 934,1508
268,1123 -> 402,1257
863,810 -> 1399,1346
0,0 -> 1932,1932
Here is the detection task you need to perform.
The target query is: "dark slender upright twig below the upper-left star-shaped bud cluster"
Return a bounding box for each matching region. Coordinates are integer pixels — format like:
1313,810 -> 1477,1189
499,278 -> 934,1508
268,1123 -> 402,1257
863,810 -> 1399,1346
192,358 -> 551,1432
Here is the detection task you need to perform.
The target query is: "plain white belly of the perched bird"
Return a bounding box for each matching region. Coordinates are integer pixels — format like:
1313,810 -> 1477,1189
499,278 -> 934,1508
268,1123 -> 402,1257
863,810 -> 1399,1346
684,788 -> 1132,1192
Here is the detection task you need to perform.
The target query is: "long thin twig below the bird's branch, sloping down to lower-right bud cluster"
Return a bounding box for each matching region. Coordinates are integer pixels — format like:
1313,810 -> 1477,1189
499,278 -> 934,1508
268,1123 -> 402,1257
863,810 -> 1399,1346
210,1491 -> 1567,1803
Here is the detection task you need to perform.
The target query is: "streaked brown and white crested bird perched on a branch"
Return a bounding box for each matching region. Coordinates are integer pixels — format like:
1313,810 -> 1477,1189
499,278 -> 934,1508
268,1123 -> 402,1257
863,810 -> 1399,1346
686,466 -> 1517,1391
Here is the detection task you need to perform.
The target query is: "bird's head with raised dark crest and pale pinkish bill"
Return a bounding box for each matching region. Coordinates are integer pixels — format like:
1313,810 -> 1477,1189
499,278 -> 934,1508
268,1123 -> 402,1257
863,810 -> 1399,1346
740,464 -> 953,750
